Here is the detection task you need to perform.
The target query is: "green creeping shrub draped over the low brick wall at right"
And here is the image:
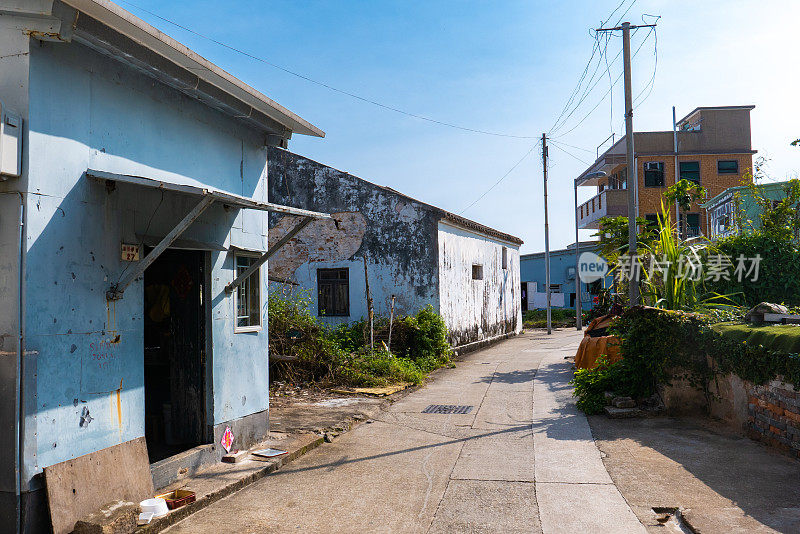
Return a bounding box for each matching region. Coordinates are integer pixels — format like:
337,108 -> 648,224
573,306 -> 800,413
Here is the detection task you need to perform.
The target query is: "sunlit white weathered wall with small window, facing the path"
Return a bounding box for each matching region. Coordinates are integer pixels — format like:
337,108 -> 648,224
438,221 -> 522,345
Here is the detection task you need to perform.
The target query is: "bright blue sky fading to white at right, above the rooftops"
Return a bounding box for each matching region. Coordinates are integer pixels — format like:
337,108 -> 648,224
120,0 -> 800,253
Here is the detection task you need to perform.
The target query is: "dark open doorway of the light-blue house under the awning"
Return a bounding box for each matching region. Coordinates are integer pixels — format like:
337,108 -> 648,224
144,249 -> 206,462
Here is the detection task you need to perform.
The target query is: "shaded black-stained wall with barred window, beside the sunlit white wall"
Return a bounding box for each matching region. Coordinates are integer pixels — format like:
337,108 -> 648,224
269,148 -> 439,323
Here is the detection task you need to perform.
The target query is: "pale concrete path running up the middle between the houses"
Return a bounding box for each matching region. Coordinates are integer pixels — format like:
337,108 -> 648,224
167,330 -> 645,534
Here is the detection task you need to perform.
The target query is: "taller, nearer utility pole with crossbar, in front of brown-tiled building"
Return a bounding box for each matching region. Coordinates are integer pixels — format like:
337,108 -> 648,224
597,22 -> 655,306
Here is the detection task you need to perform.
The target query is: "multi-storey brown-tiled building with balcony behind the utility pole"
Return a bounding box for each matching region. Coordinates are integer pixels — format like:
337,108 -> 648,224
576,106 -> 755,236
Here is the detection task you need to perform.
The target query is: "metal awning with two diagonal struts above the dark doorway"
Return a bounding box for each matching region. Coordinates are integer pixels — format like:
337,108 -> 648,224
86,169 -> 331,300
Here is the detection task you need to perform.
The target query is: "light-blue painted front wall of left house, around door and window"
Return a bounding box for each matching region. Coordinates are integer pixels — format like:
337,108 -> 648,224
24,39 -> 268,484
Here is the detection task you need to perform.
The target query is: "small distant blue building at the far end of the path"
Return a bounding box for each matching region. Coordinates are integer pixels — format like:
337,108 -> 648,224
519,241 -> 612,311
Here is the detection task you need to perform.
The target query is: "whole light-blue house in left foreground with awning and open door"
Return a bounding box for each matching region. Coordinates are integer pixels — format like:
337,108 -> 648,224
0,0 -> 326,531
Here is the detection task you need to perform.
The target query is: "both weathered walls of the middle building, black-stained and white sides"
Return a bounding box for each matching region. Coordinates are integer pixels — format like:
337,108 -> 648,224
269,148 -> 522,345
